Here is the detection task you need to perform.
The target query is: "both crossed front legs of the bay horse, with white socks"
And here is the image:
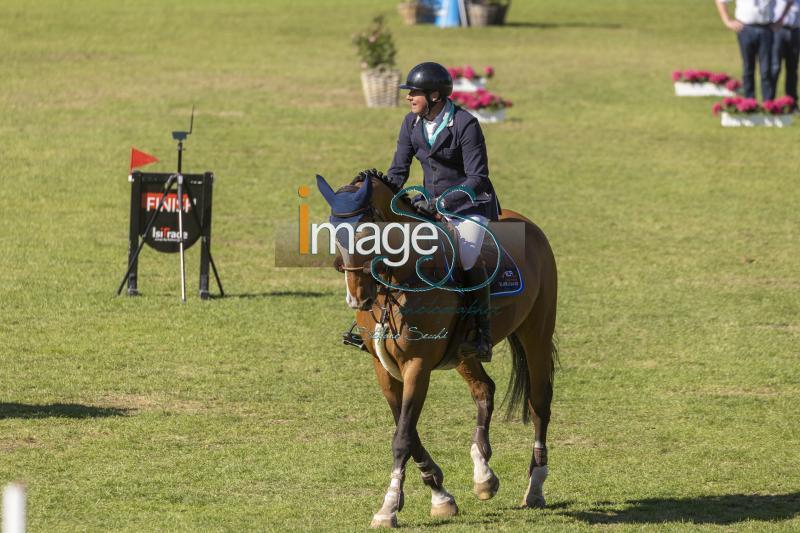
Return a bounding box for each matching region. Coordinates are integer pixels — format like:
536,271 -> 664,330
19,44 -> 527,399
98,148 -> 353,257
371,359 -> 455,527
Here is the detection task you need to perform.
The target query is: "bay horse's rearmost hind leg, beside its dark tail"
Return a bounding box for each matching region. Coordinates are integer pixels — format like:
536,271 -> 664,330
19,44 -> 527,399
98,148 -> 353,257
512,300 -> 556,507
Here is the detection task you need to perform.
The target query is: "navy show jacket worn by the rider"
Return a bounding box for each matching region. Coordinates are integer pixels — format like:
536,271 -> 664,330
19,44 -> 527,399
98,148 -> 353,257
387,104 -> 500,220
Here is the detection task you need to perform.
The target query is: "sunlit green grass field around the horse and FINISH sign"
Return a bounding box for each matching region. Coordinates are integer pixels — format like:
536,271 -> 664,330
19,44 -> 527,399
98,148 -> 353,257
0,0 -> 800,531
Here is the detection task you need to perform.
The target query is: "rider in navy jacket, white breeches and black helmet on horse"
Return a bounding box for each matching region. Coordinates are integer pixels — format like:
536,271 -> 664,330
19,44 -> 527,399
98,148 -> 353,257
387,62 -> 500,362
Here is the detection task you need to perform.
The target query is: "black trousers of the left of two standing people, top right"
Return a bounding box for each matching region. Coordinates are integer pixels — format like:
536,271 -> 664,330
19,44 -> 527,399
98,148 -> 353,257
737,24 -> 775,100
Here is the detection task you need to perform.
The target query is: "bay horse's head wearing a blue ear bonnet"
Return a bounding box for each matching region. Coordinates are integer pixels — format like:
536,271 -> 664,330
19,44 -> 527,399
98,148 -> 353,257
317,172 -> 397,310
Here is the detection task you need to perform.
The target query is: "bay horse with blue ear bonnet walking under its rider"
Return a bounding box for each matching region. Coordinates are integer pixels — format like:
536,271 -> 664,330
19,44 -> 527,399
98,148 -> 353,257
317,170 -> 557,527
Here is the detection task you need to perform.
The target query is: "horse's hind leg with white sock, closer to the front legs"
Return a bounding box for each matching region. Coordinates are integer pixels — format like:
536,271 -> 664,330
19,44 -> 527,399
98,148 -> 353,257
456,358 -> 500,500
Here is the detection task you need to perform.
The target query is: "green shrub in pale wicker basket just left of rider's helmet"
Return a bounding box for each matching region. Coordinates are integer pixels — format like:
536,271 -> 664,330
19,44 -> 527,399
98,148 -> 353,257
353,16 -> 400,107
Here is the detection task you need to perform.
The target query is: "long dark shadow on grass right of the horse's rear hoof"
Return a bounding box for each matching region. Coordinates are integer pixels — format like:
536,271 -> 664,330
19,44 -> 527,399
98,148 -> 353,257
559,492 -> 800,525
